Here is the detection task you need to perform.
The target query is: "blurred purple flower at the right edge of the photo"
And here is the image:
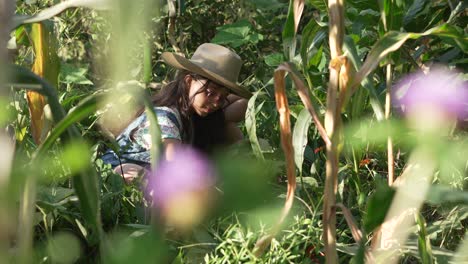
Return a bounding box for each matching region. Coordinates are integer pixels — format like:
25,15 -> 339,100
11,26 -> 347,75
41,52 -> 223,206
393,68 -> 468,120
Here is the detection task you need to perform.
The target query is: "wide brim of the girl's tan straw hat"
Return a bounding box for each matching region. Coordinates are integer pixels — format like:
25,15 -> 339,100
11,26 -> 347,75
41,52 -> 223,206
161,52 -> 252,99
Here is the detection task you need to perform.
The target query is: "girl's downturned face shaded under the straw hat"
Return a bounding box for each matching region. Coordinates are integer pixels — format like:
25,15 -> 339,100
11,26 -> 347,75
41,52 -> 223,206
186,75 -> 229,116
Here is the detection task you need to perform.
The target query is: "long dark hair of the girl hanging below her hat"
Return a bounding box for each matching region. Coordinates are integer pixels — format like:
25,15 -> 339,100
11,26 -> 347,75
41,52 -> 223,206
142,70 -> 226,153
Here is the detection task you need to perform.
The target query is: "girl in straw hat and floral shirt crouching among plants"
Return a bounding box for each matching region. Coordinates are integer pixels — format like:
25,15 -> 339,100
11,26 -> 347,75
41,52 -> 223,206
102,43 -> 251,181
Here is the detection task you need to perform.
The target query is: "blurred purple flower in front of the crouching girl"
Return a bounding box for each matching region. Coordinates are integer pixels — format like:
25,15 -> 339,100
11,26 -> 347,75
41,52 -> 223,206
148,147 -> 216,229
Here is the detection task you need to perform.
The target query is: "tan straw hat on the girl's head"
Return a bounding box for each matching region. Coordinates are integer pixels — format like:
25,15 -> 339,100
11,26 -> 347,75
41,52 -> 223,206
161,43 -> 252,99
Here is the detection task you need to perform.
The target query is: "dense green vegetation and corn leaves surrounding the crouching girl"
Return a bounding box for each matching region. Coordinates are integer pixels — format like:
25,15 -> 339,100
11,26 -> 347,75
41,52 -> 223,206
0,0 -> 468,263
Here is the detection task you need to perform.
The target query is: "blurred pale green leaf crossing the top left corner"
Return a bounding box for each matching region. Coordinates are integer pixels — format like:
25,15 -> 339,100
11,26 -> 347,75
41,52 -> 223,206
11,0 -> 111,30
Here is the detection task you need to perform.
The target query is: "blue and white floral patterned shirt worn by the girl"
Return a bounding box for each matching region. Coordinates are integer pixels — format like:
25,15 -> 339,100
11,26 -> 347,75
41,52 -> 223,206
101,106 -> 182,167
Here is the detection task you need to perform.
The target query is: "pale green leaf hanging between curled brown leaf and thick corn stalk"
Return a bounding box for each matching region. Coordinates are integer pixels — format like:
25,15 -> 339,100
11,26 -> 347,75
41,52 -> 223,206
292,108 -> 312,175
